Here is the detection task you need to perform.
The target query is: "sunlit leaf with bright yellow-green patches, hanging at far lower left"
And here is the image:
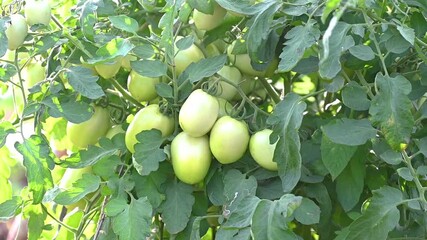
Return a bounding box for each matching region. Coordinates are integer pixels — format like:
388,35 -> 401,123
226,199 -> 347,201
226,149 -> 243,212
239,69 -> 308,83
15,135 -> 54,204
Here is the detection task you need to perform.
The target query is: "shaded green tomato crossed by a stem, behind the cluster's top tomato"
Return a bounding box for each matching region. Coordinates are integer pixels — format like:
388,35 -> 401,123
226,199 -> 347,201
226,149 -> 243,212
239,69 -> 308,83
210,66 -> 242,100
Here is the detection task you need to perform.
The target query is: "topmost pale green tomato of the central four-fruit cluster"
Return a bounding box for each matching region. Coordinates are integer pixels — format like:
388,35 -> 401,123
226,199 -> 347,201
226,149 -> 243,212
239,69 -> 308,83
179,89 -> 219,137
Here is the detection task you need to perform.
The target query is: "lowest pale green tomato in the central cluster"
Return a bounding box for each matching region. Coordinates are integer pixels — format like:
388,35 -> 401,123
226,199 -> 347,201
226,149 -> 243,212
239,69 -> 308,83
171,132 -> 212,184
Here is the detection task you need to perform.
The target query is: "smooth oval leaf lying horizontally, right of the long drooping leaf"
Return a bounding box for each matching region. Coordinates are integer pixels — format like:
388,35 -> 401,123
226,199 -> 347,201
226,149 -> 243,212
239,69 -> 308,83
322,118 -> 377,146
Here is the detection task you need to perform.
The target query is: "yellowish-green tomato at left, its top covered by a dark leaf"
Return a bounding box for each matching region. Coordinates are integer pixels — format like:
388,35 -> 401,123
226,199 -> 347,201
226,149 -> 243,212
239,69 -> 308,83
67,106 -> 111,148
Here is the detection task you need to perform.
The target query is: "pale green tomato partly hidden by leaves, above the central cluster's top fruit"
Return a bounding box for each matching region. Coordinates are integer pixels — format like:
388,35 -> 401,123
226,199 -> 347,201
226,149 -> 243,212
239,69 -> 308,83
174,36 -> 204,75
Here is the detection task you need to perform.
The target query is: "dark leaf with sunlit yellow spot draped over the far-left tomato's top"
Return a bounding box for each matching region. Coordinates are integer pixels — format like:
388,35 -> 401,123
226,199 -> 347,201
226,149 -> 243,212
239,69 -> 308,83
42,95 -> 93,123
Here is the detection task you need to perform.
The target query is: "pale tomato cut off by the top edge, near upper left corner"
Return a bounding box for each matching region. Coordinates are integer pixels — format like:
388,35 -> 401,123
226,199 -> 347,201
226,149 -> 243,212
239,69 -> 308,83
25,0 -> 51,26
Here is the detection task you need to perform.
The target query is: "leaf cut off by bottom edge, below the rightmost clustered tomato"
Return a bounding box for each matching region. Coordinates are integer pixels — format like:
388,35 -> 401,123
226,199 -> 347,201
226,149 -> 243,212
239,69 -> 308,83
251,194 -> 302,240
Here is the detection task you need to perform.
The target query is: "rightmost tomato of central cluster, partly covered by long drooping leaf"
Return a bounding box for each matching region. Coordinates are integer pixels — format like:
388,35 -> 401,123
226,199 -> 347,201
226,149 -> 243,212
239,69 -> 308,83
249,129 -> 277,171
